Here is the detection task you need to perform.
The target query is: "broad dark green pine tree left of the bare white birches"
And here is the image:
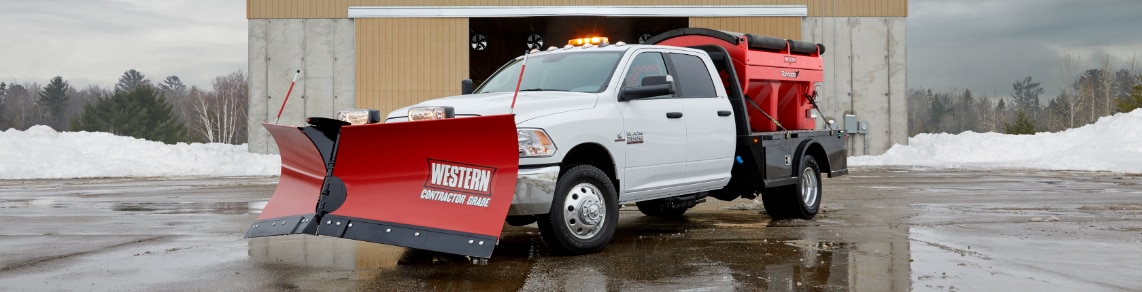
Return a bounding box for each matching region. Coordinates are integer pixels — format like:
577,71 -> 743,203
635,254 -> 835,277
71,84 -> 187,144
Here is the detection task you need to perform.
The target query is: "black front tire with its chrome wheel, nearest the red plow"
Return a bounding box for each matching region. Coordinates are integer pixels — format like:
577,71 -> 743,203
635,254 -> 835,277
537,165 -> 619,254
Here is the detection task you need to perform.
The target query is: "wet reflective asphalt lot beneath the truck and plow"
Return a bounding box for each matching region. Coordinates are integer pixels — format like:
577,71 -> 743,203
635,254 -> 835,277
0,169 -> 1142,291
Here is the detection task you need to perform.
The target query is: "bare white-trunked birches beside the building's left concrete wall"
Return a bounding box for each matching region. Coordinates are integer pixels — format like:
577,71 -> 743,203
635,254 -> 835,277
188,71 -> 249,144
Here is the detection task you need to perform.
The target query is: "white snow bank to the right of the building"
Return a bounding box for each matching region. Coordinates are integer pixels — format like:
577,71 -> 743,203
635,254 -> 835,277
849,110 -> 1142,173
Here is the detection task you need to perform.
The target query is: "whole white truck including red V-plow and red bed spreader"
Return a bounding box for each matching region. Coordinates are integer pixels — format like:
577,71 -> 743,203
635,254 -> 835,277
247,29 -> 847,258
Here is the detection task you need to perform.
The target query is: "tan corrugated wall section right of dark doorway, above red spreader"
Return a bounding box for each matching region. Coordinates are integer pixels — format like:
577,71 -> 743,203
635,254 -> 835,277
690,16 -> 802,40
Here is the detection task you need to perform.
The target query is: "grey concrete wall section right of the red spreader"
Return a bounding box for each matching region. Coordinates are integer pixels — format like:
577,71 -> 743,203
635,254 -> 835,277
802,17 -> 908,155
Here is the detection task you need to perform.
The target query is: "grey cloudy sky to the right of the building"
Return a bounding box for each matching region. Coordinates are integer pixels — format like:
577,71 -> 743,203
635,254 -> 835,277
908,0 -> 1142,96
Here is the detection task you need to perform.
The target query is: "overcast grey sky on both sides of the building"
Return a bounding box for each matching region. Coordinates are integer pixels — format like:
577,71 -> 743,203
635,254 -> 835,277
0,0 -> 1142,96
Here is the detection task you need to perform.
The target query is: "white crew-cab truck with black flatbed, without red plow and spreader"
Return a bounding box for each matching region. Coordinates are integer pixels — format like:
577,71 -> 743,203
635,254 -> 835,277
385,29 -> 847,253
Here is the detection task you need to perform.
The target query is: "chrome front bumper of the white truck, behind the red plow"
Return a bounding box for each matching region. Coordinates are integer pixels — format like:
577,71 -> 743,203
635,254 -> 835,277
507,165 -> 560,216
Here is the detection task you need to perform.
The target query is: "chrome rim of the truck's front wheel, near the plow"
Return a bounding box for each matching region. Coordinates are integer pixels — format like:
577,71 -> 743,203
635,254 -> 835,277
563,183 -> 606,240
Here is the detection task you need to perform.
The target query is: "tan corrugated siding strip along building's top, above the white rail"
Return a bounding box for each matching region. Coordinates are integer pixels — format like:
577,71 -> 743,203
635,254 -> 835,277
246,0 -> 908,18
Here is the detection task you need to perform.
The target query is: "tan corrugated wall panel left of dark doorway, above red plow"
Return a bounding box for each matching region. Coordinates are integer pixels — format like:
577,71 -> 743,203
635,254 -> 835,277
355,18 -> 468,115
